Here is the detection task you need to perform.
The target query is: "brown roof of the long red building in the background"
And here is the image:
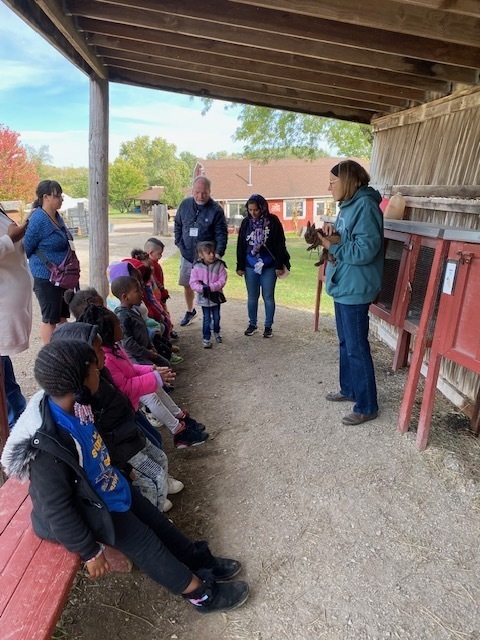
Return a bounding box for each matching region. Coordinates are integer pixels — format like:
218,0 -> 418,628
196,158 -> 368,200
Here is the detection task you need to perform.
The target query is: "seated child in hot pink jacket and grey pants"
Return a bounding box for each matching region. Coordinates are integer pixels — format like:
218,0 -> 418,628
81,305 -> 208,449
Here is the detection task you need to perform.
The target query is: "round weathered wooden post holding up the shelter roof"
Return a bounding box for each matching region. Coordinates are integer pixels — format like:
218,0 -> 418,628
88,76 -> 109,298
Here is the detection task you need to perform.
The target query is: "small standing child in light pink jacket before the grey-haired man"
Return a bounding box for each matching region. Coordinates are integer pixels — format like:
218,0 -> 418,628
190,241 -> 227,349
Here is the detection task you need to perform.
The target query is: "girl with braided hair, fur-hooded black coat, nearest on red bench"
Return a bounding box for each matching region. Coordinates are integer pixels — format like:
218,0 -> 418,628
1,340 -> 249,613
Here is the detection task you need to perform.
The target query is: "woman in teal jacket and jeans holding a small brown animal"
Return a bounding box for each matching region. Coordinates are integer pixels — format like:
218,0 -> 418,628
322,160 -> 384,425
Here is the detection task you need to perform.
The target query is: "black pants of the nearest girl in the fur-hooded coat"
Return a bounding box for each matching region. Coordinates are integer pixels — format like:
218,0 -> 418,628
111,487 -> 199,594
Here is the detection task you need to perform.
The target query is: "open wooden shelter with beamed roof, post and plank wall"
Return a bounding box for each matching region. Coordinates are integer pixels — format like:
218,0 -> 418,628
4,0 -> 480,442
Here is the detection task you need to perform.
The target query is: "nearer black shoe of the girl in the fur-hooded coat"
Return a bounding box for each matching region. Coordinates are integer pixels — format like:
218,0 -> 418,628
182,580 -> 249,613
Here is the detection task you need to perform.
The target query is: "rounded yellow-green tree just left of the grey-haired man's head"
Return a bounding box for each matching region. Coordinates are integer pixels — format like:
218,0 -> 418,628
120,136 -> 191,207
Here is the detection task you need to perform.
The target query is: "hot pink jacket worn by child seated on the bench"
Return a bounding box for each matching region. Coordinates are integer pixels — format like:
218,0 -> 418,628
103,346 -> 158,411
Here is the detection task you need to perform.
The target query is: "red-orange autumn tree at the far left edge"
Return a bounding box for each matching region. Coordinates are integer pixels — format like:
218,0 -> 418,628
0,124 -> 39,202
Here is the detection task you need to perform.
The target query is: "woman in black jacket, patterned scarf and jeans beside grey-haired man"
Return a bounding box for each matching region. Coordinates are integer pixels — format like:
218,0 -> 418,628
237,194 -> 290,338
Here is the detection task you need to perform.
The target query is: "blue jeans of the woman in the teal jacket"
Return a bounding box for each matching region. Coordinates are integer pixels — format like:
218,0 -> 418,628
335,302 -> 378,413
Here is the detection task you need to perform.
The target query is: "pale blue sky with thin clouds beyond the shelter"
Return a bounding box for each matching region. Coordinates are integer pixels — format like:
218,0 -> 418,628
0,2 -> 246,167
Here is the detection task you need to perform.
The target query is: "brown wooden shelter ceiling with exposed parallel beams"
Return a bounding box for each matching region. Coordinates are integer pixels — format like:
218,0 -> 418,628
4,0 -> 480,123
